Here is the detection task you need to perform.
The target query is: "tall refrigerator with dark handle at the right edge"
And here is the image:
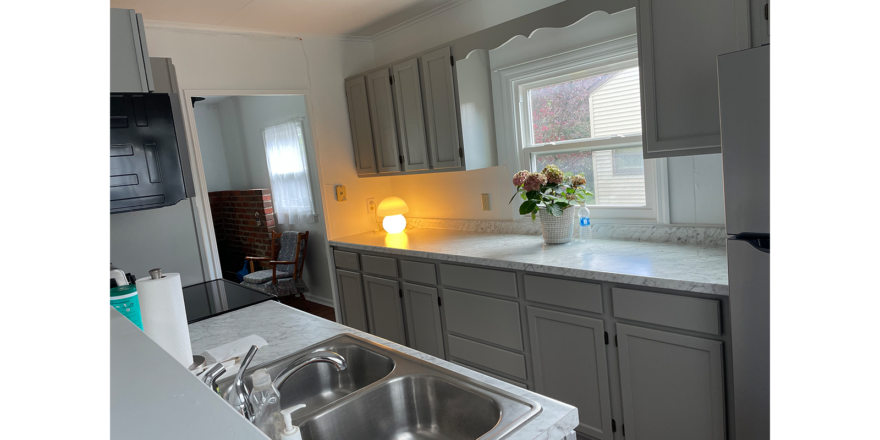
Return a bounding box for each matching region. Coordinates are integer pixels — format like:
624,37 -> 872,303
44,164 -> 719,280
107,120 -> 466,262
718,45 -> 772,440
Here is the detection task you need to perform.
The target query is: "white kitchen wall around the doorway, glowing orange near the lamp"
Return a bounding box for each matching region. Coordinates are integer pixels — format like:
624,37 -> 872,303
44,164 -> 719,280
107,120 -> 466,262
109,25 -> 391,296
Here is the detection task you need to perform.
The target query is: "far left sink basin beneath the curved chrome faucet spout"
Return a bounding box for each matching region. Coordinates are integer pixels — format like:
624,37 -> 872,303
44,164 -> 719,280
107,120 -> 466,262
217,337 -> 394,424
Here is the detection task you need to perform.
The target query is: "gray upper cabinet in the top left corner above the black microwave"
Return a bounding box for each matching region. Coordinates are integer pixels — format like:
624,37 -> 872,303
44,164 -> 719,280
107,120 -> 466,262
110,8 -> 153,93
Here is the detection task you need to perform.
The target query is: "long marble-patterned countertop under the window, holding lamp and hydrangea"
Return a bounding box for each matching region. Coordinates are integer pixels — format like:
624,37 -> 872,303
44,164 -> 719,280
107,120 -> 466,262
330,229 -> 729,296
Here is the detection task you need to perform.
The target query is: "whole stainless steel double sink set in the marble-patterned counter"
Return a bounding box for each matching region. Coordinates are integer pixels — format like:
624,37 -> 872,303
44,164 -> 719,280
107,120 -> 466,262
217,334 -> 541,440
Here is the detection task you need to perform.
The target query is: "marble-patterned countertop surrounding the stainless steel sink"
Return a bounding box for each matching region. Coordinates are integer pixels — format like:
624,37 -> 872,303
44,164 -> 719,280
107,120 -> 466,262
189,301 -> 578,440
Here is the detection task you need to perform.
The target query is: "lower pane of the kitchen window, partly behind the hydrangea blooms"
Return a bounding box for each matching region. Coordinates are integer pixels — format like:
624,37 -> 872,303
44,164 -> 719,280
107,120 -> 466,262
534,147 -> 646,206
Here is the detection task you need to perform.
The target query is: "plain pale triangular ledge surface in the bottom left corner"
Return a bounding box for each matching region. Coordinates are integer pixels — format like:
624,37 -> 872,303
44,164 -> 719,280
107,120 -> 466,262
108,306 -> 267,440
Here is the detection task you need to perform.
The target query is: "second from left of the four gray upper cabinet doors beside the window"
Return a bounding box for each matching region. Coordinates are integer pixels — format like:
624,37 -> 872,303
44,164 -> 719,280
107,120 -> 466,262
367,69 -> 401,173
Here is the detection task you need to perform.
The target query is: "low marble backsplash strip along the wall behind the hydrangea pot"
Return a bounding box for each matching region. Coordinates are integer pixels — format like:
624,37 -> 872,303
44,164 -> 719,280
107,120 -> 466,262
406,217 -> 727,246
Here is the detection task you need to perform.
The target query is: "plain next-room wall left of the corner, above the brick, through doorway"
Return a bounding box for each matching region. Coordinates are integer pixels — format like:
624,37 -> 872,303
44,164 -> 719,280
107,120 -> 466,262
193,104 -> 232,192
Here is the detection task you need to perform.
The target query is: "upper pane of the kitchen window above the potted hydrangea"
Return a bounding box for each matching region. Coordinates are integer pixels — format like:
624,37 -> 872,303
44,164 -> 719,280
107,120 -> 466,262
528,67 -> 642,144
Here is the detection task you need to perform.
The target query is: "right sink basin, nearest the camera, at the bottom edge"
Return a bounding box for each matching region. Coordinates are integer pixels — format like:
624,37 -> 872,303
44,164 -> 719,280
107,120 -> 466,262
300,376 -> 501,440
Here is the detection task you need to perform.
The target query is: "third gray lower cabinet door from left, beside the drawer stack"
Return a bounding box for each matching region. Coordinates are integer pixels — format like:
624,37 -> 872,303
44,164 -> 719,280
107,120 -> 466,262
403,283 -> 446,359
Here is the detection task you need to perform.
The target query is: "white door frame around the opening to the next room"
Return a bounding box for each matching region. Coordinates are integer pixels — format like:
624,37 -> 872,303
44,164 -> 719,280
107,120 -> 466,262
183,89 -> 340,312
